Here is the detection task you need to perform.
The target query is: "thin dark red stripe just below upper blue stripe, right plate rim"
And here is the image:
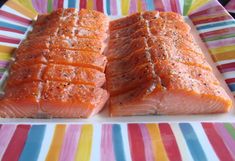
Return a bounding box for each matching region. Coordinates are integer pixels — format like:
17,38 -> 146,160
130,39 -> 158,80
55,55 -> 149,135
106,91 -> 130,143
200,27 -> 235,38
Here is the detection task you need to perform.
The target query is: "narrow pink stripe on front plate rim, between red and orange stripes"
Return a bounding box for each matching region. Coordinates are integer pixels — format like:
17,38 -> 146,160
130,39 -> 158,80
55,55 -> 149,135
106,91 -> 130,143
139,124 -> 154,161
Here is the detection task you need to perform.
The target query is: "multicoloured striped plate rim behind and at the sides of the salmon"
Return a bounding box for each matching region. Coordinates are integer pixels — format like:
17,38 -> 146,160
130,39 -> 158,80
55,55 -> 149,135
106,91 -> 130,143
0,0 -> 235,93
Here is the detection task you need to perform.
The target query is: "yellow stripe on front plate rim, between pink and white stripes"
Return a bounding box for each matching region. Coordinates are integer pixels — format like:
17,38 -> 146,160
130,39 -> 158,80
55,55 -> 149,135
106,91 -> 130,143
75,125 -> 93,161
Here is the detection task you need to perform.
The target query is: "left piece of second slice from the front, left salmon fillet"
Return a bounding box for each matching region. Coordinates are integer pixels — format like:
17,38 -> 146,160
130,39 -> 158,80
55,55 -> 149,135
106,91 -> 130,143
7,64 -> 46,88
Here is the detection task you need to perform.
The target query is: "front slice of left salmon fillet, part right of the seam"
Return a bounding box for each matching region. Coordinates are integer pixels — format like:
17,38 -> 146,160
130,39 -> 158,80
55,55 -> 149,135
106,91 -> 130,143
40,81 -> 109,118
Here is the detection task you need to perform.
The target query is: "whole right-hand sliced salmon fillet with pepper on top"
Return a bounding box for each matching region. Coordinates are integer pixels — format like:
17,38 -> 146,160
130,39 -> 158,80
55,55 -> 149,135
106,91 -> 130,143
106,11 -> 232,116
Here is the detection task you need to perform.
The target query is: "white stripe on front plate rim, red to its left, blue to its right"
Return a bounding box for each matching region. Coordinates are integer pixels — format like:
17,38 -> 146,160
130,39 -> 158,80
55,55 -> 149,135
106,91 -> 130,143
170,123 -> 193,161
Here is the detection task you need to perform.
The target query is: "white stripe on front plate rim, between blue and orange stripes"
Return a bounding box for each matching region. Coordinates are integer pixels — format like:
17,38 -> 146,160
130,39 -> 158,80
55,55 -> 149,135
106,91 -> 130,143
38,124 -> 55,161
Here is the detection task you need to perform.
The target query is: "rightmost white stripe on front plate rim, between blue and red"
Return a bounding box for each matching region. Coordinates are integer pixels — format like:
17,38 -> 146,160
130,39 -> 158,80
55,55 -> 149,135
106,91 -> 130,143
191,122 -> 219,161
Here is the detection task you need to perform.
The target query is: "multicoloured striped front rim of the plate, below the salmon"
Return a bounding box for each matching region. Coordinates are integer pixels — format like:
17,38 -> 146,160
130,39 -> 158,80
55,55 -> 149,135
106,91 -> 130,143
0,123 -> 235,161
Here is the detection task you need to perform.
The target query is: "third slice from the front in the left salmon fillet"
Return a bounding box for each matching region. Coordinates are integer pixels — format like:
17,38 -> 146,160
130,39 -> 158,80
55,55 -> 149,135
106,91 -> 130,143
12,49 -> 107,72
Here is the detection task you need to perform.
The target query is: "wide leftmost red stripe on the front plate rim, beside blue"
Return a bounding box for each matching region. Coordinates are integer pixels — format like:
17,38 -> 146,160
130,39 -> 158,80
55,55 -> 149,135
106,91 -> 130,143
2,125 -> 30,161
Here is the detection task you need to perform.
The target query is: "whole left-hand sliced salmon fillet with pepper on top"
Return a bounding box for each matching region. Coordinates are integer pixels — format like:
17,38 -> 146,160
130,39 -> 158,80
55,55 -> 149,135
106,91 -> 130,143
0,9 -> 109,118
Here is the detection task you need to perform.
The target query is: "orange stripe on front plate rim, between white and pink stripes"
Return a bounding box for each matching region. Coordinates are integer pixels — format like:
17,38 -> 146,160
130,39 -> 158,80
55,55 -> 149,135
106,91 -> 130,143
46,125 -> 66,161
